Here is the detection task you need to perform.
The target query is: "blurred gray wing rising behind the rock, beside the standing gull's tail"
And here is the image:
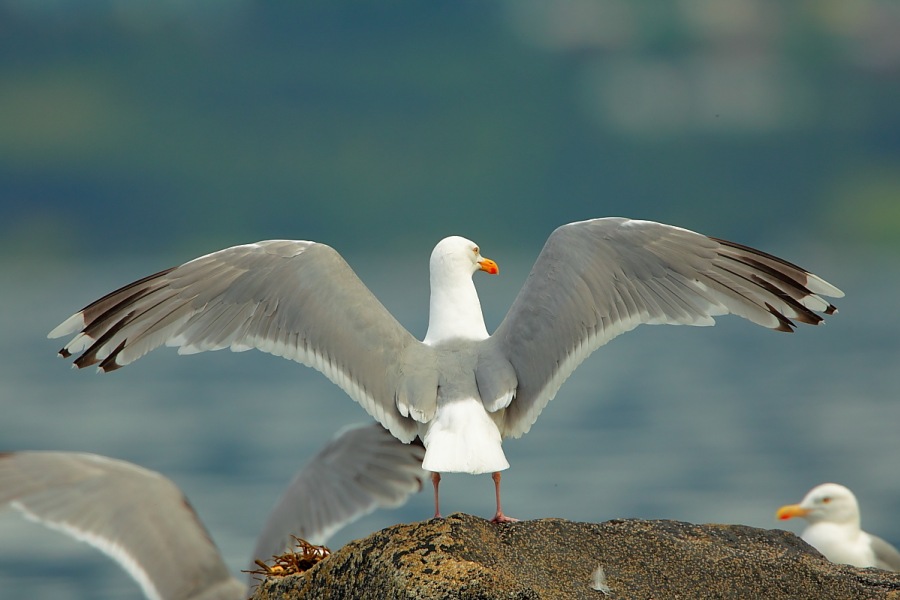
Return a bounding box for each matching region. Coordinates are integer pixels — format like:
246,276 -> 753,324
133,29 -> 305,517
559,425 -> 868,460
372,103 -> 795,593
252,424 -> 427,572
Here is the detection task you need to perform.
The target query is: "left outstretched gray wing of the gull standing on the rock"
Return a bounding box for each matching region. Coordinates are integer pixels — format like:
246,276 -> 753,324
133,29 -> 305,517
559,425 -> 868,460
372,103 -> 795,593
49,240 -> 429,441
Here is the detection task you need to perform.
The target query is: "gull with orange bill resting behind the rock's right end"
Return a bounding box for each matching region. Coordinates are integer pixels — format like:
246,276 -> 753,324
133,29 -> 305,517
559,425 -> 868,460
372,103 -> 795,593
776,483 -> 900,571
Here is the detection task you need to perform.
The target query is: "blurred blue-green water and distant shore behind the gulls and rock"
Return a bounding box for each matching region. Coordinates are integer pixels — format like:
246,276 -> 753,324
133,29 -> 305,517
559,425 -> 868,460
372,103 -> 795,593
0,0 -> 900,600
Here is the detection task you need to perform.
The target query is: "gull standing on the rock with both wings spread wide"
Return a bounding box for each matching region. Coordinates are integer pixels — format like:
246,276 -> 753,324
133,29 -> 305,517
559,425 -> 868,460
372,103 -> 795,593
50,218 -> 843,521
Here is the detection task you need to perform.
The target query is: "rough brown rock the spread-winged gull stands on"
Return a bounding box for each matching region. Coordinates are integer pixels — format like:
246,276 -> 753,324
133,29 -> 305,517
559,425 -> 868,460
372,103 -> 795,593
253,514 -> 900,600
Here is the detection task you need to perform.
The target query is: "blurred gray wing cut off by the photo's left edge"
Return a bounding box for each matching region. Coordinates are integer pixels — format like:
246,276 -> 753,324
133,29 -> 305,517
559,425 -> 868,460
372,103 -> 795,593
0,452 -> 246,600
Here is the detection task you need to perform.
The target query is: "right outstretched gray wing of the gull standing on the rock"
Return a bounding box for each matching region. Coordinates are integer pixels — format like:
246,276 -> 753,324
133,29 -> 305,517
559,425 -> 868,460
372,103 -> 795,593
479,218 -> 843,437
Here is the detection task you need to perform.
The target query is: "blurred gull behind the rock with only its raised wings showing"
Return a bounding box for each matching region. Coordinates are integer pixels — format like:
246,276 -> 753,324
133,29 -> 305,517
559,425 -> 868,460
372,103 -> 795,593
0,424 -> 426,600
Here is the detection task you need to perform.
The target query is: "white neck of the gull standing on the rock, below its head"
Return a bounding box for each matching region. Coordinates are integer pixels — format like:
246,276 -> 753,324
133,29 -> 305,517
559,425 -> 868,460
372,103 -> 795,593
423,267 -> 488,346
